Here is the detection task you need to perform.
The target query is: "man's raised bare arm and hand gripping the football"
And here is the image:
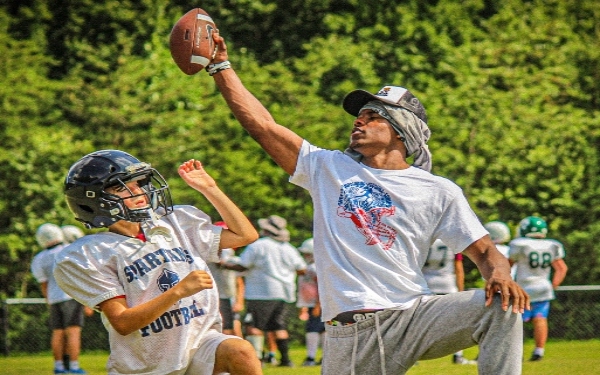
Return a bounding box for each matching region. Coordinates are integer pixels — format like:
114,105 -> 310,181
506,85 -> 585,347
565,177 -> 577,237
213,33 -> 302,175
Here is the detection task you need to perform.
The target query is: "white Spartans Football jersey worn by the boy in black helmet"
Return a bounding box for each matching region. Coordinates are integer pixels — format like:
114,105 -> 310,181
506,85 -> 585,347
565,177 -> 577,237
54,206 -> 222,374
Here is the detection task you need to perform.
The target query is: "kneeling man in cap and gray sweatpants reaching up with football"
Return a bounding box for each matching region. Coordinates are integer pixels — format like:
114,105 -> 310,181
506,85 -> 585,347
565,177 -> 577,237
207,32 -> 529,375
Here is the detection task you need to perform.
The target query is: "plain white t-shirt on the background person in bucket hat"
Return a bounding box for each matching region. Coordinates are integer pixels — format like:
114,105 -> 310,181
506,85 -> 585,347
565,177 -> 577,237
239,237 -> 306,303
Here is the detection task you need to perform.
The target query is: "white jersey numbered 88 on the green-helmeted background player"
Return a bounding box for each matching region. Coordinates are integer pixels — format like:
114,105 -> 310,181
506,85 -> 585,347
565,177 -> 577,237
508,237 -> 565,302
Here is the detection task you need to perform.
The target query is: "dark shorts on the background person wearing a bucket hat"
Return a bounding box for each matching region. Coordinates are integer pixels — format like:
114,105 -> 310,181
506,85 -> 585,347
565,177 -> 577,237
246,300 -> 294,331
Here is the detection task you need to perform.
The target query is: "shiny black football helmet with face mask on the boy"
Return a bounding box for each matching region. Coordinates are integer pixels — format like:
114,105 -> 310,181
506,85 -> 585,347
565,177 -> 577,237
64,150 -> 173,228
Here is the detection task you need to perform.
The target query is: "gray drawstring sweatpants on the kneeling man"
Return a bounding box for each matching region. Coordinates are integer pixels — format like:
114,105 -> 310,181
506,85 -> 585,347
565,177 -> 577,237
321,290 -> 523,375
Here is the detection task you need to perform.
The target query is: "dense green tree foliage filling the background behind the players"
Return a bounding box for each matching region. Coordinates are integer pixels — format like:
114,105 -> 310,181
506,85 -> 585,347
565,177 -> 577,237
0,0 -> 600,297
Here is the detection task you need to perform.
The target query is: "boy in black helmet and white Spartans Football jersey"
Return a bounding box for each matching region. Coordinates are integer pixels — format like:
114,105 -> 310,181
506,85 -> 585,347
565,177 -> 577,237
55,150 -> 262,375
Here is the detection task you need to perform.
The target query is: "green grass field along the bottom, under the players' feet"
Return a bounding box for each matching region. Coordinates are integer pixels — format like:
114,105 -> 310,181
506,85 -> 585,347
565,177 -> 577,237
0,340 -> 600,375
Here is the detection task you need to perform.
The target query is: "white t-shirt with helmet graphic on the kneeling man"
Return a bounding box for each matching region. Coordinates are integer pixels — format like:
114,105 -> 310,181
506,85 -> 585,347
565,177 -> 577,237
290,141 -> 488,321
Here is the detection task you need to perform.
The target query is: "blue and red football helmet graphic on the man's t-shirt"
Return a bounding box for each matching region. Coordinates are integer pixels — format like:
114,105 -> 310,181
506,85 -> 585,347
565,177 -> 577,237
337,182 -> 396,250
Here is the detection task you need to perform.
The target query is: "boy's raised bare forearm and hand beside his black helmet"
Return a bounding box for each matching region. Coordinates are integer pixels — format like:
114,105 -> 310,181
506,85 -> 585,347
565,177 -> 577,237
177,159 -> 258,249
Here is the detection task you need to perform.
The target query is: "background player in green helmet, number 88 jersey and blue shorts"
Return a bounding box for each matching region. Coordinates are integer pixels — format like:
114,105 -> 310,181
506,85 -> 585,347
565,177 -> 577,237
509,216 -> 568,361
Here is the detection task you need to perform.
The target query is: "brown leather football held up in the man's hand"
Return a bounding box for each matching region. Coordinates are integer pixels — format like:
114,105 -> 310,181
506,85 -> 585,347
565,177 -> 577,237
169,8 -> 217,75
